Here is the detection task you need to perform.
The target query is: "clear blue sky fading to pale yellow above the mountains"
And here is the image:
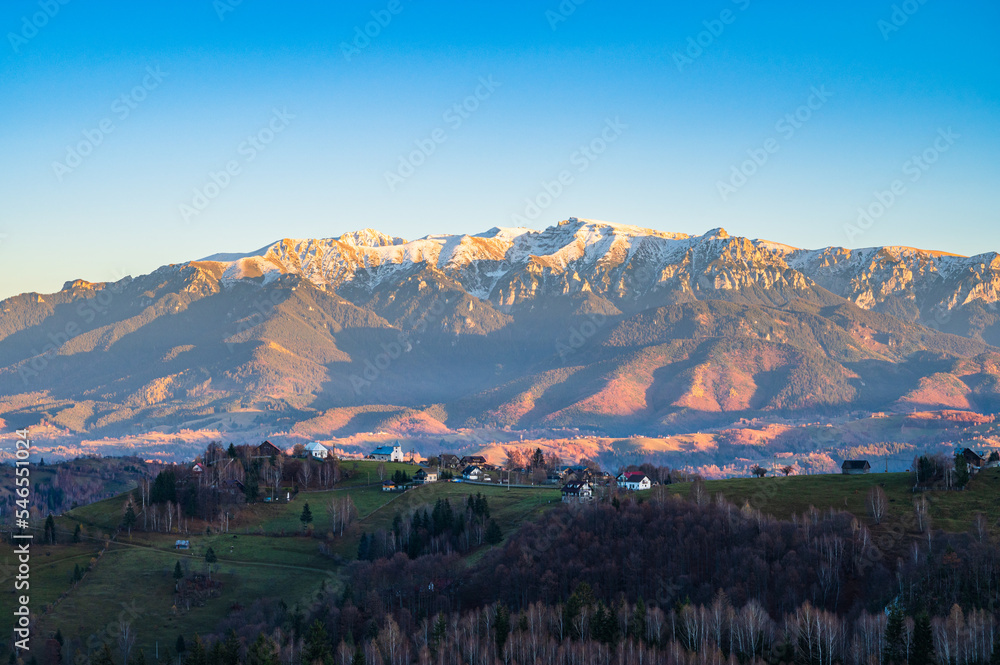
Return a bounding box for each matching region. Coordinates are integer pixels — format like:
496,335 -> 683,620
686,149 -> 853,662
0,0 -> 1000,297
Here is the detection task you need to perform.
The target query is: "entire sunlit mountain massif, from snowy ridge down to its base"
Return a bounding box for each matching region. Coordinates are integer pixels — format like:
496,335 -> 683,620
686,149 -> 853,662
0,218 -> 1000,435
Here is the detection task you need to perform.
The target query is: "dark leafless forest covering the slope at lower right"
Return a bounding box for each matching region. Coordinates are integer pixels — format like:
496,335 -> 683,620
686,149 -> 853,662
199,483 -> 1000,665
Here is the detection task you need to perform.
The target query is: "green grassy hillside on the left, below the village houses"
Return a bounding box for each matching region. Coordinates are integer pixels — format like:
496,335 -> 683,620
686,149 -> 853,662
0,472 -> 559,653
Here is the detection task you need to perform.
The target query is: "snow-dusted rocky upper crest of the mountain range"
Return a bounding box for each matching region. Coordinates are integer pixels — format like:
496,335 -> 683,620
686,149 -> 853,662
204,218 -> 1000,325
